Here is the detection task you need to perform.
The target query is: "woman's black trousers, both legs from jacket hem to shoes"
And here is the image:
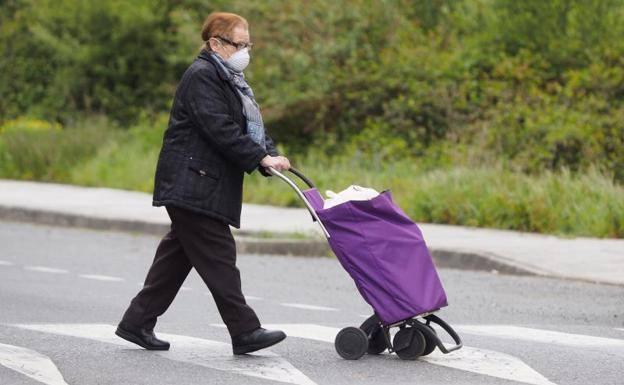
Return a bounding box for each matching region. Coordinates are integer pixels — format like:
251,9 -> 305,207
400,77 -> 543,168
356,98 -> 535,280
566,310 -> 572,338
122,207 -> 260,337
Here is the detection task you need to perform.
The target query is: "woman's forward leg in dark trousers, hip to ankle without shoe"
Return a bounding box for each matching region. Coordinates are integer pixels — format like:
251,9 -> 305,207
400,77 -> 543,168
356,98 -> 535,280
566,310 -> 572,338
167,207 -> 260,336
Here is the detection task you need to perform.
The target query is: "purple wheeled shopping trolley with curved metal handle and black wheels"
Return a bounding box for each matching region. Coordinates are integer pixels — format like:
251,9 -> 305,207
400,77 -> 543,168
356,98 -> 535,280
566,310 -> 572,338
269,168 -> 462,360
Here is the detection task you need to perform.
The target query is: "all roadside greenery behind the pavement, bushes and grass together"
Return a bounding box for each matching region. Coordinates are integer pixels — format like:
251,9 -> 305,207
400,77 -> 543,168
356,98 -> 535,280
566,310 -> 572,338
0,0 -> 624,238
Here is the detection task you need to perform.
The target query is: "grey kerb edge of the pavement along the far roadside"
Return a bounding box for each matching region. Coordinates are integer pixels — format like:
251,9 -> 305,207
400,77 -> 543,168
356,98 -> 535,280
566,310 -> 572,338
0,206 -> 565,278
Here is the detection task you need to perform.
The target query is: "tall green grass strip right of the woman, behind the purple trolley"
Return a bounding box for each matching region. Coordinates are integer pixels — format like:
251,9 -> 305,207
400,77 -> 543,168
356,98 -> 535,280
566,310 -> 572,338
245,156 -> 624,238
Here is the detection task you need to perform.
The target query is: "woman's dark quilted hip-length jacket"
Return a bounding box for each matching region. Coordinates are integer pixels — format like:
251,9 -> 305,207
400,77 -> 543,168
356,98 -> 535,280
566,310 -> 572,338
153,50 -> 277,228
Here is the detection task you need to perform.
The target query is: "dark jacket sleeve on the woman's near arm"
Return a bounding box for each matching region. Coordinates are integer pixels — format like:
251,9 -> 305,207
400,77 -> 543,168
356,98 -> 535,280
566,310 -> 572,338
186,70 -> 268,173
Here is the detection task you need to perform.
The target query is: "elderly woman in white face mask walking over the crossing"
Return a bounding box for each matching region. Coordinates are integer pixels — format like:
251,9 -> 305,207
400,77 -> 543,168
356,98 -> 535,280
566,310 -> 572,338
116,13 -> 290,354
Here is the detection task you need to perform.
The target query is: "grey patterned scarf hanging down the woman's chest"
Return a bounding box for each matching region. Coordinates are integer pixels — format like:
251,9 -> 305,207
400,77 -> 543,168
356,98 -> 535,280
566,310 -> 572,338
210,52 -> 266,149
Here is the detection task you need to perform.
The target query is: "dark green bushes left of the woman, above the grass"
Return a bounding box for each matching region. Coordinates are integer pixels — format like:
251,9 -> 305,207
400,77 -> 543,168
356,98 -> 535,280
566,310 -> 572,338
0,0 -> 197,123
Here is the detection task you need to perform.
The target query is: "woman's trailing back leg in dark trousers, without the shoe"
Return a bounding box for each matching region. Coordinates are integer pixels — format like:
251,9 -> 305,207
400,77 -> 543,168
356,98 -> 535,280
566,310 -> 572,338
121,221 -> 191,330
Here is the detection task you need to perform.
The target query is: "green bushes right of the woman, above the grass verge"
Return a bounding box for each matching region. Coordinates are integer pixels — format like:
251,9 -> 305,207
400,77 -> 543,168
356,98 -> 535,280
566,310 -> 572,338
233,0 -> 624,182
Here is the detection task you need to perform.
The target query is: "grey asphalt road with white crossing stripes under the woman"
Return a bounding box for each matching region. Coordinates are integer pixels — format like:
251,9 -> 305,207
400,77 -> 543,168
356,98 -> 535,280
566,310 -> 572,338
0,222 -> 624,385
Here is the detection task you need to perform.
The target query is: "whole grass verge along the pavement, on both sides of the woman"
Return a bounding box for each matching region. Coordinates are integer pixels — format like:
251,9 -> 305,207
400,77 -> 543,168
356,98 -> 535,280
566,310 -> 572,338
0,116 -> 624,238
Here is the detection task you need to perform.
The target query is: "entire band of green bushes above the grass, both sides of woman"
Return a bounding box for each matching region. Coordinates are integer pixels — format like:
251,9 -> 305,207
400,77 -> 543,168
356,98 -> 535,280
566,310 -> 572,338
0,0 -> 624,182
